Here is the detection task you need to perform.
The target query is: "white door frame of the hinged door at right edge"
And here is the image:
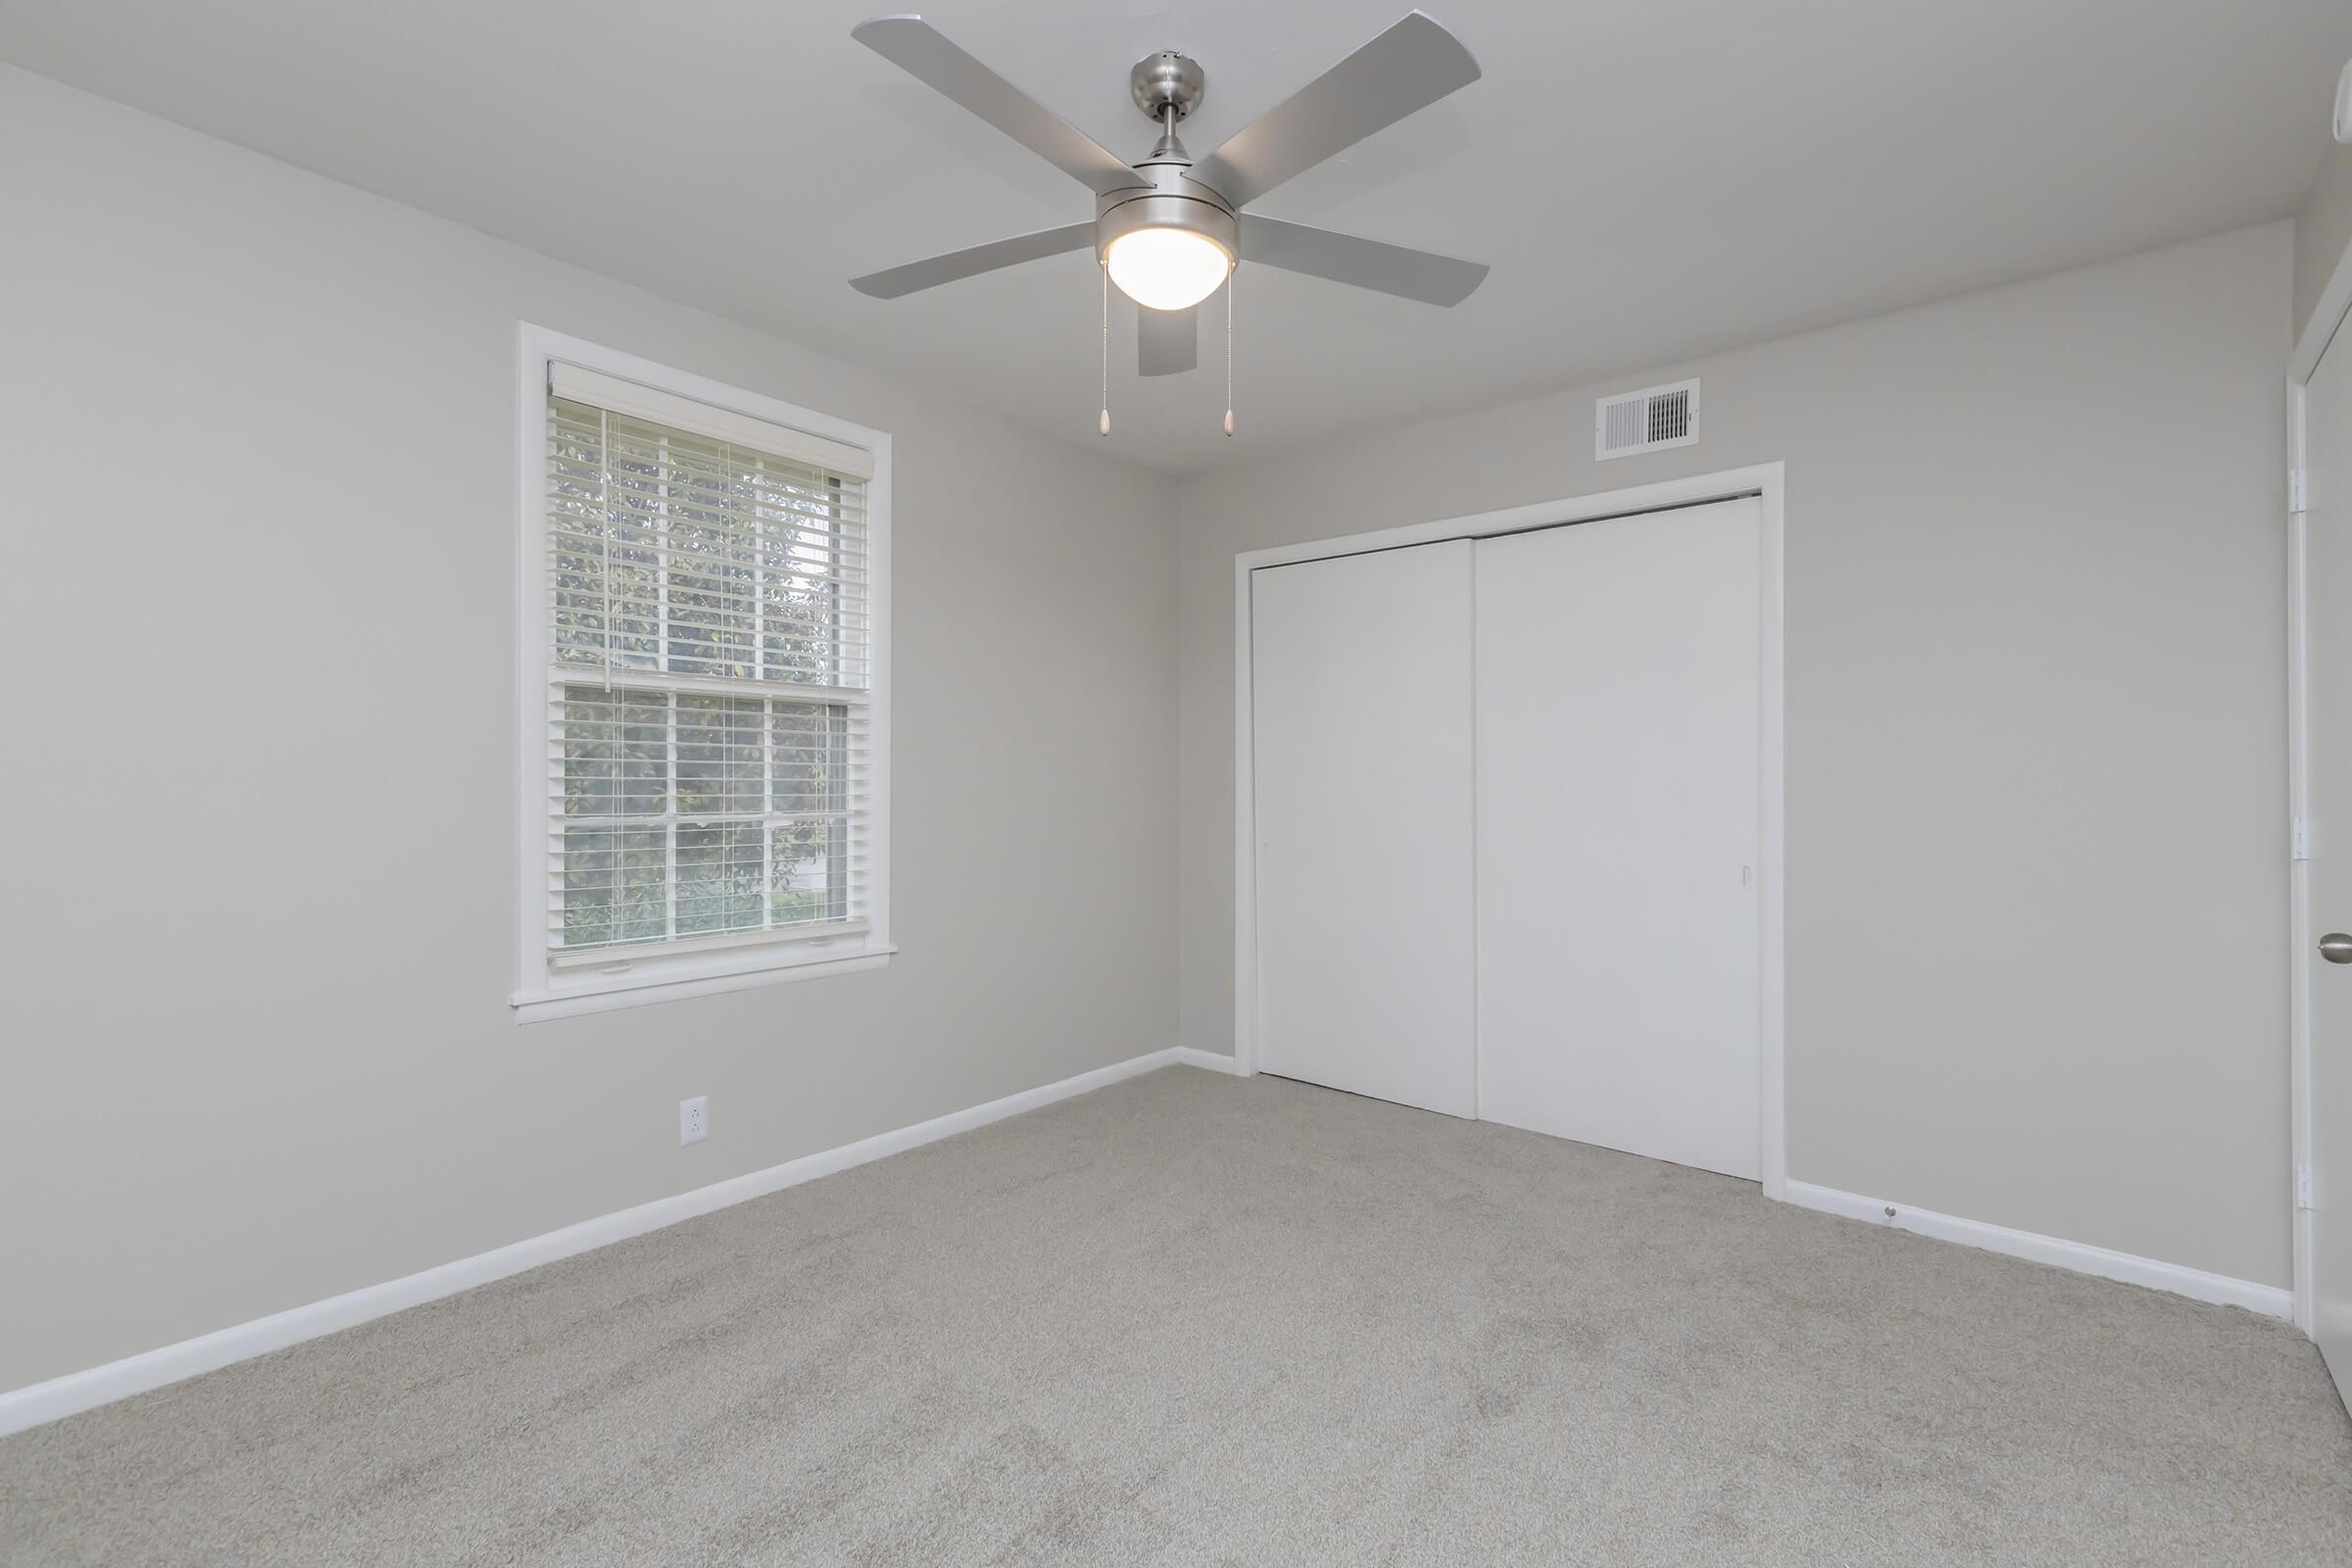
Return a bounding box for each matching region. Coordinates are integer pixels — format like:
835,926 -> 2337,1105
2286,230 -> 2352,1336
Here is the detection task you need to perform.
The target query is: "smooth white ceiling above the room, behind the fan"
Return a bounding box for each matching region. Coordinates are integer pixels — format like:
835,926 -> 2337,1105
0,0 -> 2352,472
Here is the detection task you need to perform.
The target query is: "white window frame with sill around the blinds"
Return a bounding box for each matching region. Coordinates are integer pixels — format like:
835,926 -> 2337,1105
508,322 -> 896,1022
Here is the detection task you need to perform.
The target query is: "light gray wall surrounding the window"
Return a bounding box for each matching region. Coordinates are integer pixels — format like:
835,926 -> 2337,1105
0,66 -> 1176,1387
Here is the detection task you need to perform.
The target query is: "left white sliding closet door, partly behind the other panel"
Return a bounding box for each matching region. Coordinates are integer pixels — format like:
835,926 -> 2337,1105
1249,538 -> 1477,1116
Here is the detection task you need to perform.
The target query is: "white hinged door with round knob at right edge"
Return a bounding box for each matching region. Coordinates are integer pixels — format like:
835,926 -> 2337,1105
2303,326 -> 2352,1398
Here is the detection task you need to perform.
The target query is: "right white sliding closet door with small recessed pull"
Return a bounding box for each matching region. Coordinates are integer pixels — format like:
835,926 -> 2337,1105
1477,501 -> 1768,1180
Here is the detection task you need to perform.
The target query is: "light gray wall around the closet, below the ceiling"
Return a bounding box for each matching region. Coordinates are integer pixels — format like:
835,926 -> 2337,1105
1178,223 -> 2291,1286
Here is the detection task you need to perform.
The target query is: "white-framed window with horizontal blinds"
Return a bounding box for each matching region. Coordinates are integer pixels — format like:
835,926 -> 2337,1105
515,331 -> 889,1018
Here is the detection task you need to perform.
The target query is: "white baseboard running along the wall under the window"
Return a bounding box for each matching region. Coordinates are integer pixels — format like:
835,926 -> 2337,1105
0,1046 -> 1203,1437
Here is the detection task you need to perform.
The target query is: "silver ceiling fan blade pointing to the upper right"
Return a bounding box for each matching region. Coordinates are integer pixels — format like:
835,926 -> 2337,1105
1193,12 -> 1480,207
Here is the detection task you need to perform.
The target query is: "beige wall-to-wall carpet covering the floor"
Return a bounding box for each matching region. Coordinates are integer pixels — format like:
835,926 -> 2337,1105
0,1067 -> 2352,1568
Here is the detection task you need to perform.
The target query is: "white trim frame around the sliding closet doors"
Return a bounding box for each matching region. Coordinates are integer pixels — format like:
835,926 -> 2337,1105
1233,464 -> 1788,1199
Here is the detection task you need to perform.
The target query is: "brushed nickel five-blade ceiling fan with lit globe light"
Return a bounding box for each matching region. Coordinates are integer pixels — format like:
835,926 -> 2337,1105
849,12 -> 1487,394
